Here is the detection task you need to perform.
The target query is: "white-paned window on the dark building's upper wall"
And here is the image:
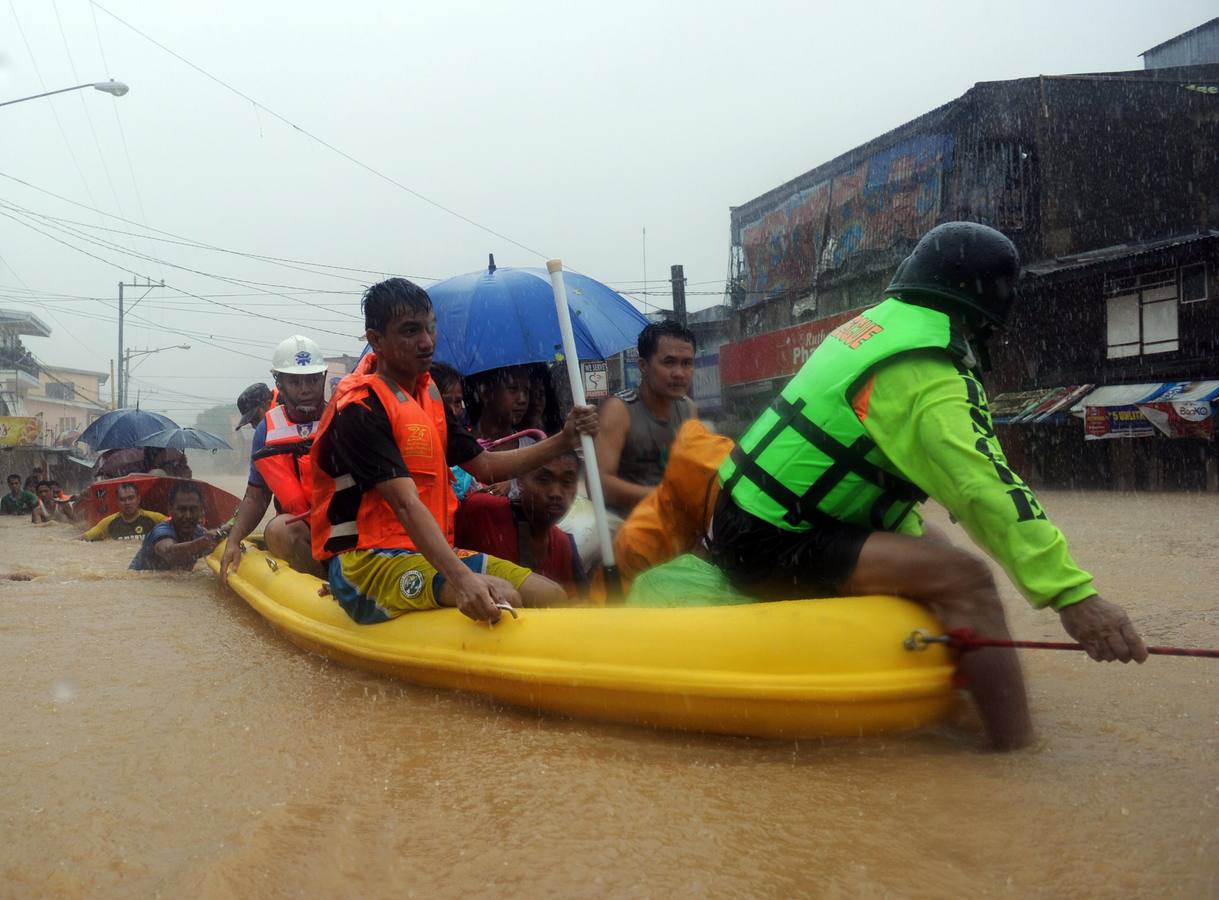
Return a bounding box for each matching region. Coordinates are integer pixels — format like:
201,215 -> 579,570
1104,268 -> 1180,360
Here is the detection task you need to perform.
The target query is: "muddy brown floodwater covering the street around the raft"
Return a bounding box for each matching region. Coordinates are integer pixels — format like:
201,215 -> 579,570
0,485 -> 1219,898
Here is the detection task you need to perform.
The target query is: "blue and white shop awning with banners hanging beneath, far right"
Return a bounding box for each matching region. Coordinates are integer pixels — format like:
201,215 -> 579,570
1072,380 -> 1219,440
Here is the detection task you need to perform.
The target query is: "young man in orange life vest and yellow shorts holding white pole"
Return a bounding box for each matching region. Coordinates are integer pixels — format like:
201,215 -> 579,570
310,278 -> 597,623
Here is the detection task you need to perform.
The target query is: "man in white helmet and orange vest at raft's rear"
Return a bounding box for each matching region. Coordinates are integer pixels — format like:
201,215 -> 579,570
221,334 -> 327,582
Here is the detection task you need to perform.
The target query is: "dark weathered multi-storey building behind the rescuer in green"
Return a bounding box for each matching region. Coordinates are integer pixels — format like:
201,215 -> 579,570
720,58 -> 1219,487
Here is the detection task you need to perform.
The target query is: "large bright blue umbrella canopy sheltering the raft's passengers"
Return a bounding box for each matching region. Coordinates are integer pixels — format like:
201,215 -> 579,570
428,260 -> 647,376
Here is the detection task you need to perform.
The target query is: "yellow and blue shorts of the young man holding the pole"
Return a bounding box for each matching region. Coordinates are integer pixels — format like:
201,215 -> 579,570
328,550 -> 533,624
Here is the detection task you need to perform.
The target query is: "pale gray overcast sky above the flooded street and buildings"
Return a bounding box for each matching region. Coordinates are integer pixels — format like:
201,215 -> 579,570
0,0 -> 1215,424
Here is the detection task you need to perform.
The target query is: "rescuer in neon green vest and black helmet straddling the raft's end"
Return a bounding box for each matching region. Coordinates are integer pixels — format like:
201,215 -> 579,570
711,222 -> 1147,750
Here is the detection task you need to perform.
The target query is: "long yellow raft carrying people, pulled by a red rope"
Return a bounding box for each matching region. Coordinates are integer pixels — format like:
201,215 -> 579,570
207,543 -> 953,738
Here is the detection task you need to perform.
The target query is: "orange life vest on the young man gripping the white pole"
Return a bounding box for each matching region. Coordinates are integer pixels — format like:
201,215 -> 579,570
310,352 -> 457,560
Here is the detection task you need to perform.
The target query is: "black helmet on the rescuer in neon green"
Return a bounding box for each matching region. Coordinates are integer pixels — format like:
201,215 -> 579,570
887,222 -> 1020,327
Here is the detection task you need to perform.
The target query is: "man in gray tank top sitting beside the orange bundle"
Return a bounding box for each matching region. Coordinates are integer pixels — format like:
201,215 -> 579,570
596,320 -> 698,517
